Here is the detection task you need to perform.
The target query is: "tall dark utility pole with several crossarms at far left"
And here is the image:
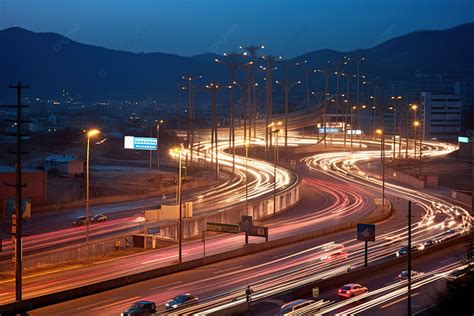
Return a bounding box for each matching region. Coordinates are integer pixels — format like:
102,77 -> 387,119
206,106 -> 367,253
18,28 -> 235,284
2,82 -> 30,302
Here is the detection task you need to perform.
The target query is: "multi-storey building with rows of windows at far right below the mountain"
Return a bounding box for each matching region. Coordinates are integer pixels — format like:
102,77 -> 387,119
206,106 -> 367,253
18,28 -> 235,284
421,92 -> 463,141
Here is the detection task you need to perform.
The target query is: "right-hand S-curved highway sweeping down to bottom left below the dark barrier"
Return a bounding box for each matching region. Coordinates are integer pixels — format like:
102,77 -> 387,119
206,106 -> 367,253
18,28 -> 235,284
20,137 -> 472,314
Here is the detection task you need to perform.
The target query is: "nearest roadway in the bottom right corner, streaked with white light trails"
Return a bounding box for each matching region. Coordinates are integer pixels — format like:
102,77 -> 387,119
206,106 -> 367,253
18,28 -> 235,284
250,244 -> 466,315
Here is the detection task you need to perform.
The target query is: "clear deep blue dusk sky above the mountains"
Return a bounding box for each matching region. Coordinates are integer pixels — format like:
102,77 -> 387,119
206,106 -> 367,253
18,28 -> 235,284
0,0 -> 474,57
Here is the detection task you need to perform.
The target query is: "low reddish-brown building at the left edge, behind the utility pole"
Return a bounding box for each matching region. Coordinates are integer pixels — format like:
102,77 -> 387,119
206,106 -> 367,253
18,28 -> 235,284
0,166 -> 48,216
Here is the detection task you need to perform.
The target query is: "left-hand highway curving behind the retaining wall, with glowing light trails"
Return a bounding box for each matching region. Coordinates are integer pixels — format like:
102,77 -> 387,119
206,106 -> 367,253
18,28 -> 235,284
0,135 -> 298,260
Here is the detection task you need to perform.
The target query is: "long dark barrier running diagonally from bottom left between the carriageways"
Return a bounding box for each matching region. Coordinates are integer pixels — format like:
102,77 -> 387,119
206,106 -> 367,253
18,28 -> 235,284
0,200 -> 392,315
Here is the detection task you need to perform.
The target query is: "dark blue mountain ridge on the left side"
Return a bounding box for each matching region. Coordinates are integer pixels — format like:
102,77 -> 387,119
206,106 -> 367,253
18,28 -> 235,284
0,27 -> 225,98
